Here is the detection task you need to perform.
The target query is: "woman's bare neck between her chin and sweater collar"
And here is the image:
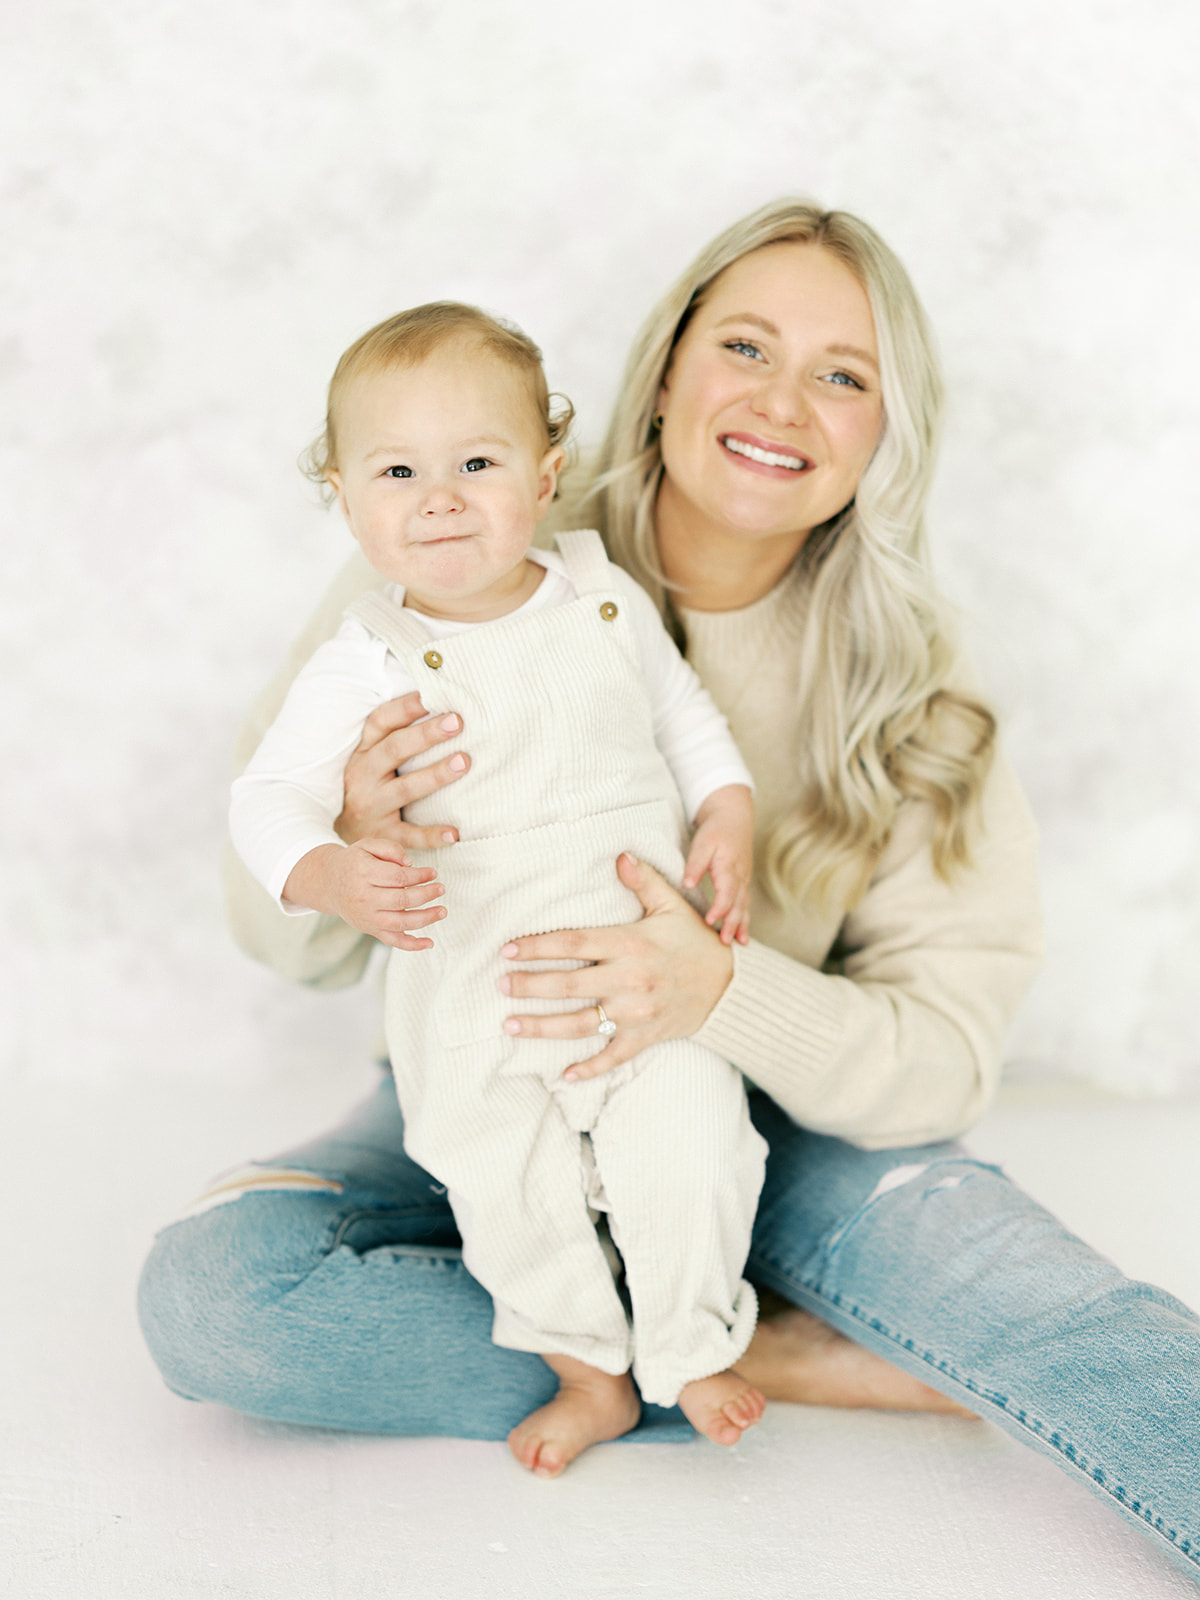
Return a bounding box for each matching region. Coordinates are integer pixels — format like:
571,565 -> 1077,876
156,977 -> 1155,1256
654,478 -> 808,611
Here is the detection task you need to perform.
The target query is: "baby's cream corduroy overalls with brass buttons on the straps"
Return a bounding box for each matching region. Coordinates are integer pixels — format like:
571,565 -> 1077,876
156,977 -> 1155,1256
347,530 -> 765,1405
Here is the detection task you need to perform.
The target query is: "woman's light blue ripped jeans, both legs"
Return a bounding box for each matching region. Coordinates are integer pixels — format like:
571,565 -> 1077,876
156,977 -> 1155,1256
139,1077 -> 1200,1581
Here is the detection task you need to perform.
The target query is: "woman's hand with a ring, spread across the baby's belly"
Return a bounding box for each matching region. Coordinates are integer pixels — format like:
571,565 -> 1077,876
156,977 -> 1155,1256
501,856 -> 733,1082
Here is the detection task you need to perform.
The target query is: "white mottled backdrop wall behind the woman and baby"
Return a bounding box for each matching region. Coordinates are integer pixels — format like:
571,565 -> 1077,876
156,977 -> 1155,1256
0,0 -> 1200,1093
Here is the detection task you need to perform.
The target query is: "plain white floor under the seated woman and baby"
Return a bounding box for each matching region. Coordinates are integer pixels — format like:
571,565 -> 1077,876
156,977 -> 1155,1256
0,1078 -> 1200,1600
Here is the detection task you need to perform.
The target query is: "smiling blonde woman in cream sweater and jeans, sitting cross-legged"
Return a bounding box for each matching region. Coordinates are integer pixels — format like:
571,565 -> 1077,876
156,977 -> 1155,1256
141,202 -> 1200,1574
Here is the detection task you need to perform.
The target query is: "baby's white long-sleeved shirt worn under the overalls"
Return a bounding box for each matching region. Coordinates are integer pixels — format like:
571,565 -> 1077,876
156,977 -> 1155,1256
229,549 -> 754,915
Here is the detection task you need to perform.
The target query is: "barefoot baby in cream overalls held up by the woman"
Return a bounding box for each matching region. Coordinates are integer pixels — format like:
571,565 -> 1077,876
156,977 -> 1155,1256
230,302 -> 765,1477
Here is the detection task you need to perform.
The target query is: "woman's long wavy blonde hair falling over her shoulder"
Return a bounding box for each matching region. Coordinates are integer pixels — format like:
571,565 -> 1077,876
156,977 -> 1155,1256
581,200 -> 995,906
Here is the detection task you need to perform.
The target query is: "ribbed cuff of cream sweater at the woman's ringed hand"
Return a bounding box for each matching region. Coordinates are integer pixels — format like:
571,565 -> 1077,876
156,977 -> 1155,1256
694,939 -> 843,1109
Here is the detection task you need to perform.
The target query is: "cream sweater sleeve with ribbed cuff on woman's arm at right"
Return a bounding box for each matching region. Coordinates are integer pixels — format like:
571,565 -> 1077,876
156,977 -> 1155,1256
696,757 -> 1042,1149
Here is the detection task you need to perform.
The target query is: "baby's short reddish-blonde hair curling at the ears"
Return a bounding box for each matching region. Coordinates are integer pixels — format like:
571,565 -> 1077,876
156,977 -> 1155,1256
299,301 -> 574,493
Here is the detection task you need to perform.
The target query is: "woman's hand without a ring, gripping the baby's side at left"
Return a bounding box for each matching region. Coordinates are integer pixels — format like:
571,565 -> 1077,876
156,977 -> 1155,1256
333,690 -> 470,850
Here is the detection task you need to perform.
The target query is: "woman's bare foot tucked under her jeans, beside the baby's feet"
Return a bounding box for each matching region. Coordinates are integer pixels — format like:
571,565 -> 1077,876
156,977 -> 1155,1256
738,1291 -> 974,1416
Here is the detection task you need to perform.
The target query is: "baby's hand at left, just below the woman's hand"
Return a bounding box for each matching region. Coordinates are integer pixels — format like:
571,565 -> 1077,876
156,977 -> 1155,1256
283,838 -> 446,950
